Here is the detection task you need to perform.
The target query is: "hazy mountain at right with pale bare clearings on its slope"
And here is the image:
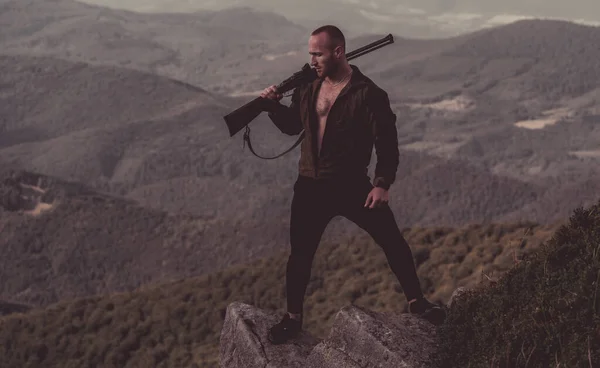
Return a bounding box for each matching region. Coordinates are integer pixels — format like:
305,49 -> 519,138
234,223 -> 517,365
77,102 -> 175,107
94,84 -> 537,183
376,21 -> 600,180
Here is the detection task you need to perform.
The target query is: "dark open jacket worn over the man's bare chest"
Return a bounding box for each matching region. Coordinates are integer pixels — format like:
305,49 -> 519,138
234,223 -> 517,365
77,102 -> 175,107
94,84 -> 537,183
269,65 -> 399,189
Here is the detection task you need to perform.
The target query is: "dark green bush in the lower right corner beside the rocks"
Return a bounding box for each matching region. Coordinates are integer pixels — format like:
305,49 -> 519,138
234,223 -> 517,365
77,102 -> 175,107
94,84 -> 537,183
437,201 -> 600,368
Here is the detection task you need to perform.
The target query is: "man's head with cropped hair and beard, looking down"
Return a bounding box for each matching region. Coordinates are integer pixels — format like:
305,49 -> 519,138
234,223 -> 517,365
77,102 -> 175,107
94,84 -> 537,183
308,25 -> 347,77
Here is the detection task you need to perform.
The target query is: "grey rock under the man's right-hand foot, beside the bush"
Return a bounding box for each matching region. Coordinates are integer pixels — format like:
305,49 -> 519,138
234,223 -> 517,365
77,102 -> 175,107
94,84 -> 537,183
306,306 -> 437,368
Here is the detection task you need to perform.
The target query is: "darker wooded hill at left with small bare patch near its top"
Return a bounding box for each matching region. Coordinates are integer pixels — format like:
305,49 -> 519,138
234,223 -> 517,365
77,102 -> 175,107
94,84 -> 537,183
0,170 -> 239,306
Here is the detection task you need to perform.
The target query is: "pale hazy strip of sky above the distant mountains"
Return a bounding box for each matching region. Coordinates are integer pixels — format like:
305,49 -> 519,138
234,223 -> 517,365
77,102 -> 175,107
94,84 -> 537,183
82,0 -> 600,37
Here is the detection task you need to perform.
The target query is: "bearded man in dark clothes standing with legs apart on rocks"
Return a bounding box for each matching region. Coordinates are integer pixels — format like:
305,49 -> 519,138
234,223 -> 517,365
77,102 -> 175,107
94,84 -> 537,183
261,25 -> 445,344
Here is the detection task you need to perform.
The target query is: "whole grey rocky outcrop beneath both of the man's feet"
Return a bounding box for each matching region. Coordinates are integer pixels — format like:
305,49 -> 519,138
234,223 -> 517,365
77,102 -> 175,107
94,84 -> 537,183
220,288 -> 466,368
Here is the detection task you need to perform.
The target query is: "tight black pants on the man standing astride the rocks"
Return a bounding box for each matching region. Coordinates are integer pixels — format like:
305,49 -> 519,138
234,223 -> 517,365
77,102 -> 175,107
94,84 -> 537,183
286,175 -> 423,314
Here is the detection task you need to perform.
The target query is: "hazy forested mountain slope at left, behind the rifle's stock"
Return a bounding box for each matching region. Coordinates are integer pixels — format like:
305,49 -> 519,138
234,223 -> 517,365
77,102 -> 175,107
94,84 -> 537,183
0,56 -> 302,246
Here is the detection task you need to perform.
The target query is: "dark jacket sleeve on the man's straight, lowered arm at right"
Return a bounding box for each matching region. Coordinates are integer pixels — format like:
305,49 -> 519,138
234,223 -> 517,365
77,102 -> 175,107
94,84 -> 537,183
366,87 -> 400,189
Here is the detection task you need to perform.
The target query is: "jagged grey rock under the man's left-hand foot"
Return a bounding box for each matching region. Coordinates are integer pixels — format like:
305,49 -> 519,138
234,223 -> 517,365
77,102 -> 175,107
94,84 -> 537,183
219,302 -> 319,368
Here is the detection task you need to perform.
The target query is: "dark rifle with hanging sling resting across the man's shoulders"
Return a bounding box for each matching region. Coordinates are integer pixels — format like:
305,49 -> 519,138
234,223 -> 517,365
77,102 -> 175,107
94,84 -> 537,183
223,34 -> 394,160
